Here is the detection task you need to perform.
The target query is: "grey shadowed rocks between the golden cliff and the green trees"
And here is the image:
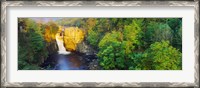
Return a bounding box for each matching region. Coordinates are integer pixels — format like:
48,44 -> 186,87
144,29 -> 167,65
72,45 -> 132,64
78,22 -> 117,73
76,41 -> 96,55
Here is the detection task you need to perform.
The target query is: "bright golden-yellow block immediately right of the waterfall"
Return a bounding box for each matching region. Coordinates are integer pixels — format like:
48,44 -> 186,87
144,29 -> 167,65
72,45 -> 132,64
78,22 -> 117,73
64,27 -> 85,51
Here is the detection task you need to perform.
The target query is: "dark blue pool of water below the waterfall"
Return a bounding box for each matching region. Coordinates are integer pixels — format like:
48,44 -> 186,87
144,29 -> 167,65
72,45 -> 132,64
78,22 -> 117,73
41,52 -> 88,70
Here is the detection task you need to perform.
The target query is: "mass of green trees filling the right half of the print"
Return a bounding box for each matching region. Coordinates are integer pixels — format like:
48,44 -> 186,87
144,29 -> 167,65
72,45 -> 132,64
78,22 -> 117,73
98,19 -> 181,70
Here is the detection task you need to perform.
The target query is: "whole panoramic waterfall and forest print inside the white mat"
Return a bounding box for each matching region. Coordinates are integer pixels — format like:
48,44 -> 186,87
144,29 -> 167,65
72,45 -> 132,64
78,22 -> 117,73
18,17 -> 182,70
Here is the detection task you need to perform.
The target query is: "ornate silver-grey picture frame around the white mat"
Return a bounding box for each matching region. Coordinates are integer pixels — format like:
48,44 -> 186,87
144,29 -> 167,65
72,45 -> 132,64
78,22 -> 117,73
1,1 -> 199,87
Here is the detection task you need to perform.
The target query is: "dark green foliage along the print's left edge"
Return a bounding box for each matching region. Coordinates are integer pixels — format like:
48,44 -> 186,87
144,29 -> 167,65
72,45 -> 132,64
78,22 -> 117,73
18,18 -> 48,70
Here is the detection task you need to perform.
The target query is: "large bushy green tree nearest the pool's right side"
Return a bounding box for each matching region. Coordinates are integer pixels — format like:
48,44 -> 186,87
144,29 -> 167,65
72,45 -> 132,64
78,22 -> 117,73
98,31 -> 124,69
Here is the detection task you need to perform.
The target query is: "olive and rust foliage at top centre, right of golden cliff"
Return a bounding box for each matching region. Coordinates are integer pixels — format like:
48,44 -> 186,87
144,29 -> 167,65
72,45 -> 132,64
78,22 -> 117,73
85,18 -> 132,48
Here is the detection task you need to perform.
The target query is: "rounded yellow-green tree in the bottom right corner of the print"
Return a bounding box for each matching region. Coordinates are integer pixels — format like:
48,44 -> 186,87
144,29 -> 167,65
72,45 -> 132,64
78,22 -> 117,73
142,41 -> 182,70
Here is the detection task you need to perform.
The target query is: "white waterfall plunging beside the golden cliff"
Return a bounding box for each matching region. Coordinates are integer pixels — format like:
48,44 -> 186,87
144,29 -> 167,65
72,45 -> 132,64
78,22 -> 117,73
56,33 -> 70,54
